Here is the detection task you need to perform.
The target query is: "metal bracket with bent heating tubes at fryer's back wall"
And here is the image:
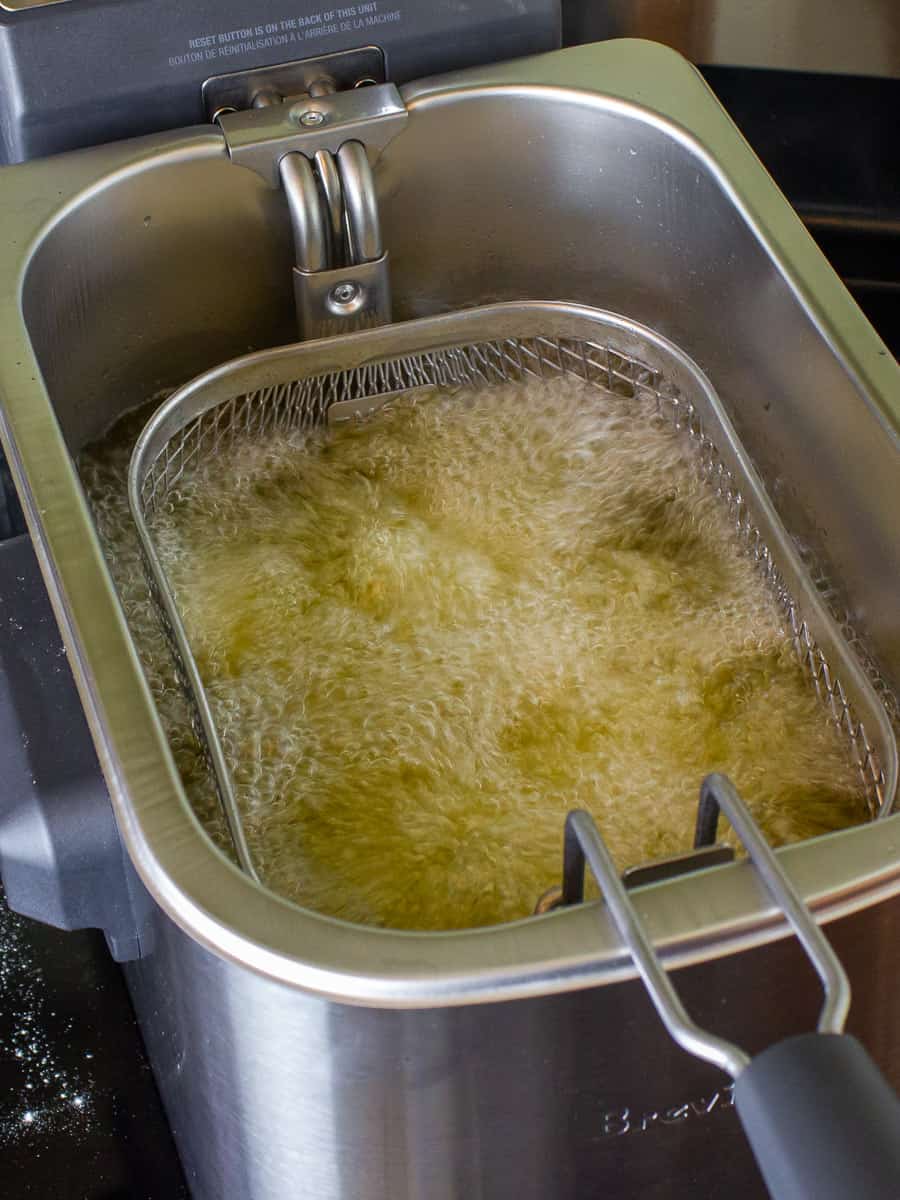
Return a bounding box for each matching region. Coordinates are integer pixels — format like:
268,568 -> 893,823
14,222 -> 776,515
203,46 -> 407,338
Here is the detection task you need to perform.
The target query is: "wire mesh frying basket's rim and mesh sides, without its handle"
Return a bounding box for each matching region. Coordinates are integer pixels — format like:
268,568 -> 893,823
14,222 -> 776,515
128,302 -> 898,878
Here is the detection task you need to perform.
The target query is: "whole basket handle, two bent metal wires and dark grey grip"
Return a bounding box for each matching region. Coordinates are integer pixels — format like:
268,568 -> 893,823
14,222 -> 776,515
565,774 -> 900,1200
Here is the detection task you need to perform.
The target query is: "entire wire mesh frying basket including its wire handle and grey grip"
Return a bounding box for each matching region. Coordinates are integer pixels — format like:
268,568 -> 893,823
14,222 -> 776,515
128,302 -> 900,1200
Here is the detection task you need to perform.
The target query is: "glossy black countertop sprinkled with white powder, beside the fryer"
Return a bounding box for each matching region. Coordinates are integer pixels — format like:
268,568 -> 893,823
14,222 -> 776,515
0,888 -> 187,1200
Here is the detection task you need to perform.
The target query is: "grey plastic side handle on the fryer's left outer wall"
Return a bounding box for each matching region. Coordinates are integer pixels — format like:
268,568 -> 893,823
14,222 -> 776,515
0,536 -> 151,962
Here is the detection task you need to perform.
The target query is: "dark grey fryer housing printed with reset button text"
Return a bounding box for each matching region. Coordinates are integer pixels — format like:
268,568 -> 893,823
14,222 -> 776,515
0,0 -> 562,164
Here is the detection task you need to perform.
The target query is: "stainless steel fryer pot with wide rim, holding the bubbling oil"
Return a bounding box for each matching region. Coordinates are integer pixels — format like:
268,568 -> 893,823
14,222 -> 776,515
0,42 -> 900,1200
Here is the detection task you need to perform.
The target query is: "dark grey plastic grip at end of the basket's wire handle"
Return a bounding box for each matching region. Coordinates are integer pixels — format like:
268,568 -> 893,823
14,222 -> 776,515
734,1033 -> 900,1200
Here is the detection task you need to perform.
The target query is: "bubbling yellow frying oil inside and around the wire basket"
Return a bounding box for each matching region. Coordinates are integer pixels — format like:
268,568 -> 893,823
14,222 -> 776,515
83,379 -> 865,929
